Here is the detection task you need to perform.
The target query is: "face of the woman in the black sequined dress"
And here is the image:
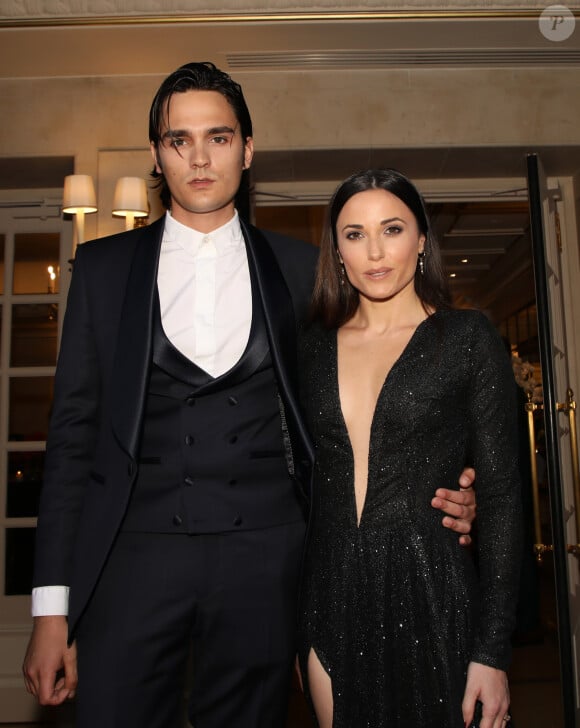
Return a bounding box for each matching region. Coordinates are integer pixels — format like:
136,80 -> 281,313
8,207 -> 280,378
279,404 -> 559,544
336,189 -> 425,301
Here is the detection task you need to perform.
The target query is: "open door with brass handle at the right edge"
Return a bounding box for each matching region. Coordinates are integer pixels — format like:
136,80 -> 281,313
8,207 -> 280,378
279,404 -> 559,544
527,154 -> 580,728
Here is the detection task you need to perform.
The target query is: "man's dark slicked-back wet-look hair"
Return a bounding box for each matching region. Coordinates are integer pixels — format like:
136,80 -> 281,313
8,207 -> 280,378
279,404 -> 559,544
149,61 -> 252,209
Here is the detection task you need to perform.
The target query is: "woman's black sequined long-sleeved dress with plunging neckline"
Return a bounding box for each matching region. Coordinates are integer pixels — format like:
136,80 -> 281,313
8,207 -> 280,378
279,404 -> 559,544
299,311 -> 521,728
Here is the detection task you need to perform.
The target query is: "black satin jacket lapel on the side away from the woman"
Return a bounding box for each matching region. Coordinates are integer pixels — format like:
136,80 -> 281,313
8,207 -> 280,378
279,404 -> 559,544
111,217 -> 165,458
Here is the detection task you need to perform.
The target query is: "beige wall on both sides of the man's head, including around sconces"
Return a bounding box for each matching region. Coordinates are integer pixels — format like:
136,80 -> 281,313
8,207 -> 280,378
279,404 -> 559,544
0,68 -> 580,235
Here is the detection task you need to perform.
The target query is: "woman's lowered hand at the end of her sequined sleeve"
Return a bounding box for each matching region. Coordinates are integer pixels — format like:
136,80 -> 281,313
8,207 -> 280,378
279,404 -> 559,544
462,662 -> 511,728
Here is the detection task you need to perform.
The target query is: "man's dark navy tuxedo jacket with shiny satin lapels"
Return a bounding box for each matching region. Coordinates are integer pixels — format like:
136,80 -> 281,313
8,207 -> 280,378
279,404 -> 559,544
33,213 -> 316,637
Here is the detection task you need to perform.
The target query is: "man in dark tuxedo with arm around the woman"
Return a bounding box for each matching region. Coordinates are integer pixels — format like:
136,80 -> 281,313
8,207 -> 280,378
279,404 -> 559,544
24,63 -> 473,728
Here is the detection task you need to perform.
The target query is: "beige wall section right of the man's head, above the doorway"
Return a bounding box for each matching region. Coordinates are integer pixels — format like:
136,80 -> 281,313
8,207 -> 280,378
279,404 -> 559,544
245,68 -> 580,149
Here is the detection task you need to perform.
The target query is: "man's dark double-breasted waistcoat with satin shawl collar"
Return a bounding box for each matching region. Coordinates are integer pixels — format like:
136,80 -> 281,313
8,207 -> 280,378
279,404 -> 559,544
123,286 -> 303,533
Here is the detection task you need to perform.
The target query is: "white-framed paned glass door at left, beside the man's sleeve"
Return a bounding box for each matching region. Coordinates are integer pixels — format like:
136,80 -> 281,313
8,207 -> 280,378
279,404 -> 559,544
0,200 -> 70,722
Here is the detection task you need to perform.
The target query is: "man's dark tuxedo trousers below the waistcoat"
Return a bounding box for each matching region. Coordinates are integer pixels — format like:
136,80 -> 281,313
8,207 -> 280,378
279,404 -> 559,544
76,523 -> 305,728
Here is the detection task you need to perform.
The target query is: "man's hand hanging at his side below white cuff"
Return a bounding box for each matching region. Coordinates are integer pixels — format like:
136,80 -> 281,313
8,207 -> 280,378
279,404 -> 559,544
22,615 -> 78,705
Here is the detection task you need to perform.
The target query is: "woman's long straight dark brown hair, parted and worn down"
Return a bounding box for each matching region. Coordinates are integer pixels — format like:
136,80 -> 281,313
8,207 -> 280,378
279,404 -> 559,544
310,169 -> 451,328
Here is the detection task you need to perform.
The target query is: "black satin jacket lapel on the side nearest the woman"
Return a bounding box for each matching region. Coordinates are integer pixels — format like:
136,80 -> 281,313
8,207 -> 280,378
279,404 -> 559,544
242,222 -> 297,398
